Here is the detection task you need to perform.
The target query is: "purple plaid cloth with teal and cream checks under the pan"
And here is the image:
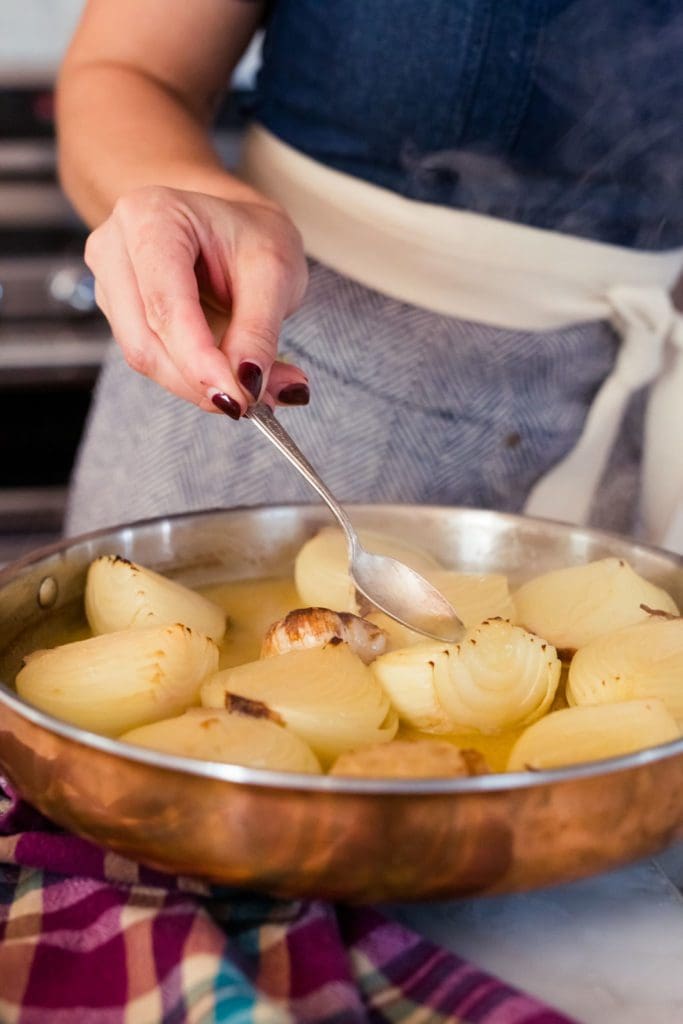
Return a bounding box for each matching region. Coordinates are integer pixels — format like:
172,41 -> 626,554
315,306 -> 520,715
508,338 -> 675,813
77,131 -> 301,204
0,778 -> 569,1024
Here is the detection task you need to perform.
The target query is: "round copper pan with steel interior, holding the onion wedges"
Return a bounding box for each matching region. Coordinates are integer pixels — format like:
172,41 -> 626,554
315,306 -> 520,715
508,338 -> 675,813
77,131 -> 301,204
0,506 -> 683,901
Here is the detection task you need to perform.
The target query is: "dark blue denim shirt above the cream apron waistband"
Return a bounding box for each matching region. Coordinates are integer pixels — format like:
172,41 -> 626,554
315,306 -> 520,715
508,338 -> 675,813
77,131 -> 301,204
252,0 -> 683,250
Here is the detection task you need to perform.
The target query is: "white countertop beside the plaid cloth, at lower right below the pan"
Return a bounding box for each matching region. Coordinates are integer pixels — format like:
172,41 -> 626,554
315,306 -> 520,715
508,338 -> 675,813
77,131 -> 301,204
383,846 -> 683,1024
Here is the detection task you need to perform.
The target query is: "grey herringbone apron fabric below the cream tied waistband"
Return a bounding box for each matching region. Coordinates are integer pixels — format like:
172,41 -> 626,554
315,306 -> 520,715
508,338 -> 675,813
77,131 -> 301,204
66,263 -> 642,536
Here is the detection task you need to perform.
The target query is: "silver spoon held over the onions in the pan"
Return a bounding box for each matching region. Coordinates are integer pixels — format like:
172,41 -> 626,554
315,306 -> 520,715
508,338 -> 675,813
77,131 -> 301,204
245,402 -> 465,643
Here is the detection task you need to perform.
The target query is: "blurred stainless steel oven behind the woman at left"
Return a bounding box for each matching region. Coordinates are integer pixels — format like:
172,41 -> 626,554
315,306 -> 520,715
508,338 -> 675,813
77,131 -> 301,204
0,83 -> 109,562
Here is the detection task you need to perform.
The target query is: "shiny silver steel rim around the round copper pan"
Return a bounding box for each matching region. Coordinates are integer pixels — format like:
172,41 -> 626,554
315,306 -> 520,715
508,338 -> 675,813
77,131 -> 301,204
0,503 -> 683,796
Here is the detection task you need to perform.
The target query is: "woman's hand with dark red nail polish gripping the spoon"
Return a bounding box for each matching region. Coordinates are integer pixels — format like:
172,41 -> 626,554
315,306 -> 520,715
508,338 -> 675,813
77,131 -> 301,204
85,186 -> 308,419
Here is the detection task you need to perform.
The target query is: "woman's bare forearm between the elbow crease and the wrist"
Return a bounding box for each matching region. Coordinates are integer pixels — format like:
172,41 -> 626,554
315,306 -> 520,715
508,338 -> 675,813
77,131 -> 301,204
57,61 -> 260,226
